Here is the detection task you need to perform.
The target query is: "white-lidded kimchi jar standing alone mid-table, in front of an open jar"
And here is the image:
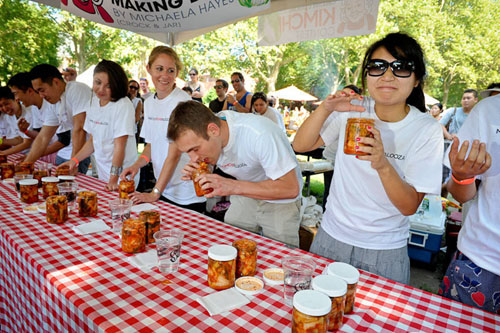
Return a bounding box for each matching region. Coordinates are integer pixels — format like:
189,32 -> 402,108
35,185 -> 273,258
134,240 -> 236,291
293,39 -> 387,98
208,245 -> 237,290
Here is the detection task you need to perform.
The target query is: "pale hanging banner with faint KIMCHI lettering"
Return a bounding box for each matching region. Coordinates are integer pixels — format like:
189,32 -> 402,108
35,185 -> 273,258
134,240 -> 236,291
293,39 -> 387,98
259,0 -> 379,46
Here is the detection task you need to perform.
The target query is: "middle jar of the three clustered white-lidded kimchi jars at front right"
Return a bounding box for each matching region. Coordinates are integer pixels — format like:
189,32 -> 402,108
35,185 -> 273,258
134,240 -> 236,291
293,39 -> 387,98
312,275 -> 347,331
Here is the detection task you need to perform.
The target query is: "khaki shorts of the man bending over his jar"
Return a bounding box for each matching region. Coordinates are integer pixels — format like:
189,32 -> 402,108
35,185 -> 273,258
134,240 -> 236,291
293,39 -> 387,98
224,195 -> 300,246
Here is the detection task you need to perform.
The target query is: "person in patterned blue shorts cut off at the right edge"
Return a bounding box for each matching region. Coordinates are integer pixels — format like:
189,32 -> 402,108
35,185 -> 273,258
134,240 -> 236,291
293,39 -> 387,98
438,94 -> 500,315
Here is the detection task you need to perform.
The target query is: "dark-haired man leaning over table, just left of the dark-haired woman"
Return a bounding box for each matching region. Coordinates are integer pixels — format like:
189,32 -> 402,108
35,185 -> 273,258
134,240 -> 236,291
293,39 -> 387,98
25,64 -> 92,173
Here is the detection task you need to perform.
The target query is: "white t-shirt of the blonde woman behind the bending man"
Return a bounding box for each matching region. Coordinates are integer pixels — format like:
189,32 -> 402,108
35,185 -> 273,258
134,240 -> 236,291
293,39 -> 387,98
140,88 -> 206,205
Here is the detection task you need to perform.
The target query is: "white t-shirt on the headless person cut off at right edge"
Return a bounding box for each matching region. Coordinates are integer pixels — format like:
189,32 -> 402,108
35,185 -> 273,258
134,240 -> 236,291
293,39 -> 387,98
445,95 -> 500,275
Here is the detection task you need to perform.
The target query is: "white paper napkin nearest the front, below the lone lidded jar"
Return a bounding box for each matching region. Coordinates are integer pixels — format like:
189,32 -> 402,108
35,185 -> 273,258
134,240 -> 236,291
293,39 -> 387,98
196,288 -> 250,316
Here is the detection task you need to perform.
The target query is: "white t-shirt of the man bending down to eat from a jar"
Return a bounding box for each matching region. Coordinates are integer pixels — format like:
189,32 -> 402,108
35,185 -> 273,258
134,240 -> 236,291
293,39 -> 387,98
217,111 -> 302,203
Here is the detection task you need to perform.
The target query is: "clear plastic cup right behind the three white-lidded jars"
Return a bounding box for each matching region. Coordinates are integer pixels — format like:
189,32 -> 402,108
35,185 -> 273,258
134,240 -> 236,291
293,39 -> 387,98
281,256 -> 316,306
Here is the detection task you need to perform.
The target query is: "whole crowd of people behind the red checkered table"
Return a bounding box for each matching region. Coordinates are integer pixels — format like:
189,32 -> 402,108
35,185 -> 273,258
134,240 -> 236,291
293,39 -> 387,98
0,33 -> 500,313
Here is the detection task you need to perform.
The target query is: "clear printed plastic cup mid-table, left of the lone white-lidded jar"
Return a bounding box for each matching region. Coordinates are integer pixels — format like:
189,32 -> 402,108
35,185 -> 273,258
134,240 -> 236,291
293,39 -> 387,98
153,229 -> 184,273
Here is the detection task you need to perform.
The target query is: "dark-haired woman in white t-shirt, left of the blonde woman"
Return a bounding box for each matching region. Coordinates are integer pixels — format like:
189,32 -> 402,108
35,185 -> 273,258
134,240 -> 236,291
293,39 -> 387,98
60,60 -> 139,191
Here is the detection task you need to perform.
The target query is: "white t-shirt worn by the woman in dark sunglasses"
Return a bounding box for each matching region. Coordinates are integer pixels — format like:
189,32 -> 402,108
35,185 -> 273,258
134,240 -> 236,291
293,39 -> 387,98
321,98 -> 443,250
